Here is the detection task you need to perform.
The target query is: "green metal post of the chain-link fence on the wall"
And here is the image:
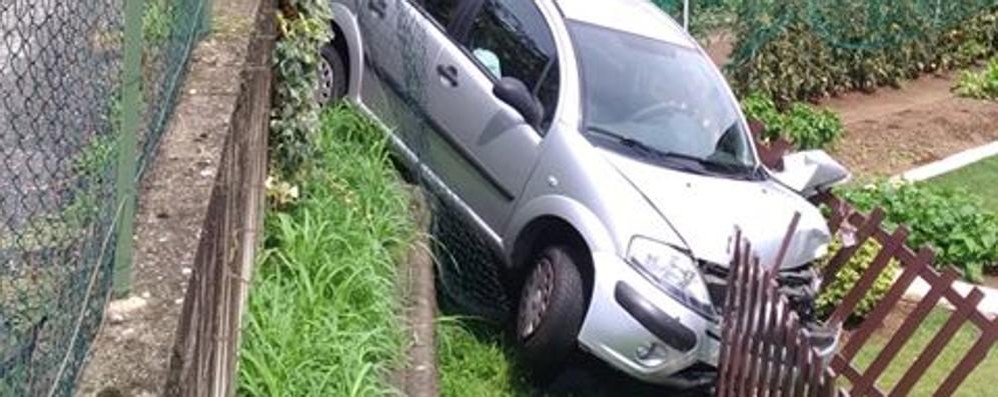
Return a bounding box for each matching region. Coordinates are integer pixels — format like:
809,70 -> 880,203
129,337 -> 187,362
114,0 -> 145,297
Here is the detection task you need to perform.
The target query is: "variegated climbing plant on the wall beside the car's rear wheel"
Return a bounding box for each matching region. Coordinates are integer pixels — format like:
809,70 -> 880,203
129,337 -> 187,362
270,0 -> 332,180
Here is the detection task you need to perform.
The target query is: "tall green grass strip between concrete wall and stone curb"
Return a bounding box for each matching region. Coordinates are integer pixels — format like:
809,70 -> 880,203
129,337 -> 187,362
238,108 -> 414,396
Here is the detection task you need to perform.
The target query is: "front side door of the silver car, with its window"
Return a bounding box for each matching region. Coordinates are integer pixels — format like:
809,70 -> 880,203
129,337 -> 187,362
426,0 -> 559,231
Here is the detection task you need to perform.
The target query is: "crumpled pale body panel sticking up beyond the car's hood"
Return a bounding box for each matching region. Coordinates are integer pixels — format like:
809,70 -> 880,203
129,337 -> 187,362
772,150 -> 852,197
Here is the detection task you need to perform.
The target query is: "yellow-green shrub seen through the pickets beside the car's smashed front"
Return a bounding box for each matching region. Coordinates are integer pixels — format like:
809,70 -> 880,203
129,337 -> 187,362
815,238 -> 901,320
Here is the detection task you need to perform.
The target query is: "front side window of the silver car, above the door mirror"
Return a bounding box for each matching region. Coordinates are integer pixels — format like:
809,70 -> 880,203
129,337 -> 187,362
464,0 -> 559,127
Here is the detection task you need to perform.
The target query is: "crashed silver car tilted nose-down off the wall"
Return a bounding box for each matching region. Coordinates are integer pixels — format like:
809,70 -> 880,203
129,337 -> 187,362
318,0 -> 848,386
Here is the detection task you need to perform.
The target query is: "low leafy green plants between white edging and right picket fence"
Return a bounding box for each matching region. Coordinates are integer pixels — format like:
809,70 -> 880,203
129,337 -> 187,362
842,183 -> 998,282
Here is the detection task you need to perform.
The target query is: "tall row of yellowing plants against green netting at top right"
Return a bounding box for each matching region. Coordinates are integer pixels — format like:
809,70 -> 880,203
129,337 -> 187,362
728,0 -> 998,105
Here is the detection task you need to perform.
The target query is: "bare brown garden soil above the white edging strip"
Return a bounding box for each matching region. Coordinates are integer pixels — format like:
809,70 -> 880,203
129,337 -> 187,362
822,76 -> 998,177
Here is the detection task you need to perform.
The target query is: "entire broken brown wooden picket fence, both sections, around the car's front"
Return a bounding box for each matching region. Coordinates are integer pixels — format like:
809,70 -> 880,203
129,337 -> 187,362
717,134 -> 998,396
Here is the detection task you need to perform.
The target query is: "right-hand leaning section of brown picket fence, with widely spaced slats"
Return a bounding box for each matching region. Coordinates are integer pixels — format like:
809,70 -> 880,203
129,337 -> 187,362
817,193 -> 998,396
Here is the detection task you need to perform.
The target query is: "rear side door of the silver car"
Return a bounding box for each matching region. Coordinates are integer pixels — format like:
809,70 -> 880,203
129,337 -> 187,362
358,0 -> 471,158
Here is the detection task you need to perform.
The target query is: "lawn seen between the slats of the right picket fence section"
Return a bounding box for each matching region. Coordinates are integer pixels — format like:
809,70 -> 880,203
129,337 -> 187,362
853,309 -> 998,396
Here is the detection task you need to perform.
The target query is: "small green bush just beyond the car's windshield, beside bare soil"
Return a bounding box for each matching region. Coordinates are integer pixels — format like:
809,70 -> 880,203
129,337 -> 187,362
742,93 -> 842,149
